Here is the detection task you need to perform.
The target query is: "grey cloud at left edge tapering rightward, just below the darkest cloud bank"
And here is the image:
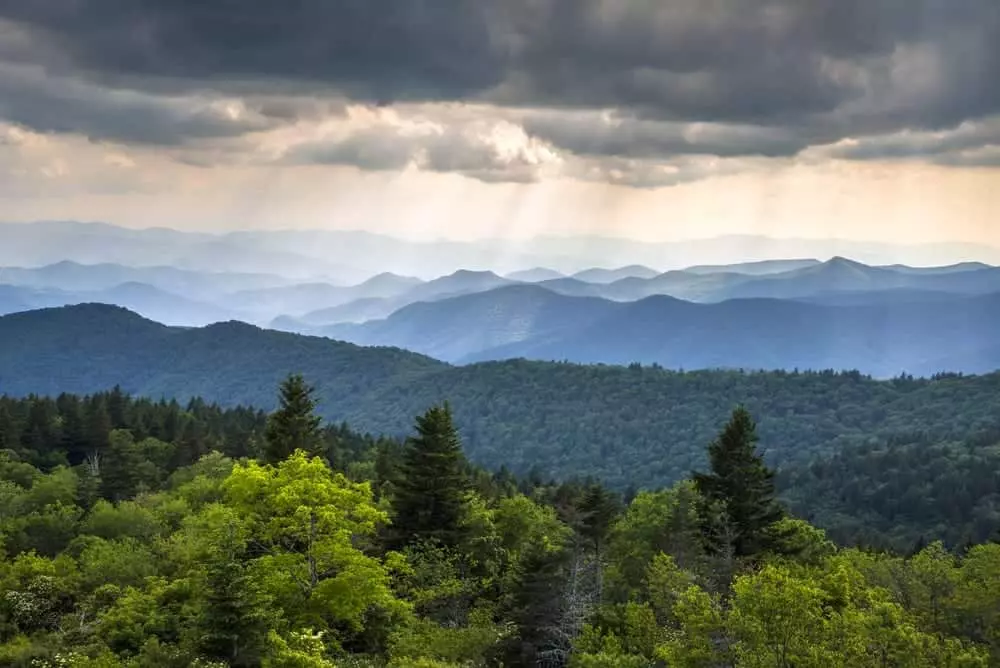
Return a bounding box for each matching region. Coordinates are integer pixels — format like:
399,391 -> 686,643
0,63 -> 268,145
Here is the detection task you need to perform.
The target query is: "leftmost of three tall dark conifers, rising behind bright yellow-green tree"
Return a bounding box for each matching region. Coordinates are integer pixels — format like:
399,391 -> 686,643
264,374 -> 323,464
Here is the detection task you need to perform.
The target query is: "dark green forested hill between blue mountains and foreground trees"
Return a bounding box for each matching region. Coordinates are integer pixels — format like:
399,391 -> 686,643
0,304 -> 1000,487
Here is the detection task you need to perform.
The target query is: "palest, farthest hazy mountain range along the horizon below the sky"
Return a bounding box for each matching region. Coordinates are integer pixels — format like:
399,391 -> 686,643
7,221 -> 1000,285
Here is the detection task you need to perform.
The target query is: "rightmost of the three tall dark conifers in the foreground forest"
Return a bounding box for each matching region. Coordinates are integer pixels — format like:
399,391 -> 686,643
694,406 -> 784,558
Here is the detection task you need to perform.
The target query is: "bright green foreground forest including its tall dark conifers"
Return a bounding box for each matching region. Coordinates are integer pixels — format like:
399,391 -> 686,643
0,384 -> 1000,668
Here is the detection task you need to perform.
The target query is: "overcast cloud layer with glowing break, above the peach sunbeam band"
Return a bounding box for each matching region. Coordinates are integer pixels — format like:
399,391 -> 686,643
0,0 -> 1000,187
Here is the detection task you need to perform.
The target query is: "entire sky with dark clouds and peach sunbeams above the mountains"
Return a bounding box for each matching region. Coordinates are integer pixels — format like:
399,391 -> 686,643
0,0 -> 1000,245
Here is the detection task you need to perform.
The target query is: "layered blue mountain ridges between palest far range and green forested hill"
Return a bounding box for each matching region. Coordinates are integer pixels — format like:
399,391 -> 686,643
0,247 -> 1000,377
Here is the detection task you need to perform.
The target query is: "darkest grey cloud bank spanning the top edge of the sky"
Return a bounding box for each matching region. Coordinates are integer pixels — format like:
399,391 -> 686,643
0,0 -> 1000,124
